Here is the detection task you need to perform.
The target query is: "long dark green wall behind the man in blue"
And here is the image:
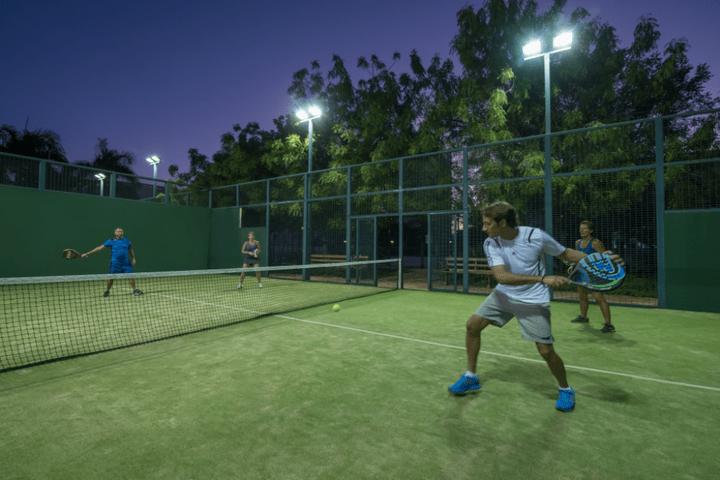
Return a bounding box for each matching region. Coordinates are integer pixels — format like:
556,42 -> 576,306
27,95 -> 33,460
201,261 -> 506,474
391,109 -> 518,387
0,186 -> 211,277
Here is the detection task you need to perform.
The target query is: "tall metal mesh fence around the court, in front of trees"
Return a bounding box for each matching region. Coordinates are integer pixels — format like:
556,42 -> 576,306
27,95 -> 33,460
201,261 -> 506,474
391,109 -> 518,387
0,109 -> 720,306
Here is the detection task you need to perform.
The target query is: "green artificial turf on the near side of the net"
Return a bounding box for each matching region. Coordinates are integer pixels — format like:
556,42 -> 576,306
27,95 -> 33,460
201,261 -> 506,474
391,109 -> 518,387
0,291 -> 720,479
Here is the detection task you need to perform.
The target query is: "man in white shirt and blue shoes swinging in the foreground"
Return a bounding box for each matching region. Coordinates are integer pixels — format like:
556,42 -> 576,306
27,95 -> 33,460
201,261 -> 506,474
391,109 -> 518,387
449,202 -> 622,412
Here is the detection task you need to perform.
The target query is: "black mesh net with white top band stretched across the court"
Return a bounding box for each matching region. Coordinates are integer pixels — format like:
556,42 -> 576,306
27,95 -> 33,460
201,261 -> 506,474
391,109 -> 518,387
0,259 -> 399,373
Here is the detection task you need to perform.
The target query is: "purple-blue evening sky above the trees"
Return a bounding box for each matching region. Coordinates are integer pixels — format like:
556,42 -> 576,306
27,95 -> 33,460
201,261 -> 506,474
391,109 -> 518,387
0,0 -> 720,182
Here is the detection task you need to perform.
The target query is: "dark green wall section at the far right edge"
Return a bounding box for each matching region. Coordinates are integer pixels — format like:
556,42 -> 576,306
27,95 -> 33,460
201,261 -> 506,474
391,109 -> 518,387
665,211 -> 720,312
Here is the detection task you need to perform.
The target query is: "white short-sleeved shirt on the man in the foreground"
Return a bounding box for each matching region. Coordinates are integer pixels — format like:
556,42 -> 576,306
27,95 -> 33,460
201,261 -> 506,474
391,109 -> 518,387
484,227 -> 565,303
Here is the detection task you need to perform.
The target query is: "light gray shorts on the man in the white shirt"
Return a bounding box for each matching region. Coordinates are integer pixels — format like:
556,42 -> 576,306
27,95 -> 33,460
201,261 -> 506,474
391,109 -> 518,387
475,290 -> 555,344
